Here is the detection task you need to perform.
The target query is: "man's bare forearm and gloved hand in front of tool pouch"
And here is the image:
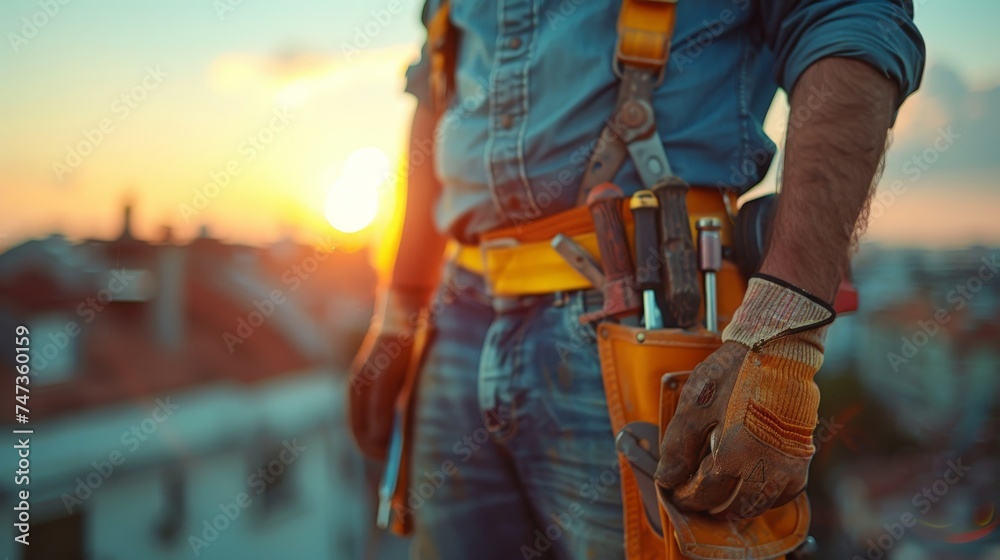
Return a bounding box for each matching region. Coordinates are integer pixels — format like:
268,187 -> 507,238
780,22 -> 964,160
657,58 -> 898,518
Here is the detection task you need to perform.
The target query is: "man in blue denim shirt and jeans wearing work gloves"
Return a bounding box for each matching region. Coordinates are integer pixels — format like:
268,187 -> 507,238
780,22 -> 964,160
352,0 -> 924,559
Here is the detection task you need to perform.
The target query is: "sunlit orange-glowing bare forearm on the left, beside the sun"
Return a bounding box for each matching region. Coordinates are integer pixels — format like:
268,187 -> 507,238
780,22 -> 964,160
391,106 -> 446,297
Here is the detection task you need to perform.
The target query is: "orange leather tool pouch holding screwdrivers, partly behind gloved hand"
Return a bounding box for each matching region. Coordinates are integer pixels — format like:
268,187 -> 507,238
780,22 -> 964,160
597,323 -> 809,560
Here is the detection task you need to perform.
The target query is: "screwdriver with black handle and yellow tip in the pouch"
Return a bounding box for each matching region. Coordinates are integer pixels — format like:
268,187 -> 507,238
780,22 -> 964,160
629,190 -> 663,329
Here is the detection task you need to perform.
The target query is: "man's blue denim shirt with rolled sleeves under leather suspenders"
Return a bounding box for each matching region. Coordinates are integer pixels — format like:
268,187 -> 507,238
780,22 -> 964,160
407,0 -> 924,240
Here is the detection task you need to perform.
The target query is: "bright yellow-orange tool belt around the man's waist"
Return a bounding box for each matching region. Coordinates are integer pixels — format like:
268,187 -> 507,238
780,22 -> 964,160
451,187 -> 736,297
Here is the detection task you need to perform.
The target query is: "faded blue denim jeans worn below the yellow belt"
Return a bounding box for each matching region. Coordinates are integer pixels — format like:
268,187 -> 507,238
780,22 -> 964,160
409,265 -> 624,560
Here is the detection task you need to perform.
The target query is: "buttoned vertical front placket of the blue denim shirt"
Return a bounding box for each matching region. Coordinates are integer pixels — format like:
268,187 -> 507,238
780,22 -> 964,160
485,0 -> 540,223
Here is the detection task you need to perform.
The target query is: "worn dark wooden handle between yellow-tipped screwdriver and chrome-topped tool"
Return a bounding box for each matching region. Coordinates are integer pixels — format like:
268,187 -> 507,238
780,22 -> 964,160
653,176 -> 701,328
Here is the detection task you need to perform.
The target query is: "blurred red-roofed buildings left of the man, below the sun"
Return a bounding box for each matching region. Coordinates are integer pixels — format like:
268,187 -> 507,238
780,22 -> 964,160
0,208 -> 390,560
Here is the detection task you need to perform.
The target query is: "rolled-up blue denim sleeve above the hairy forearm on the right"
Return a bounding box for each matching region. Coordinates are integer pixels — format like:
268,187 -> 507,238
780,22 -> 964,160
760,0 -> 926,108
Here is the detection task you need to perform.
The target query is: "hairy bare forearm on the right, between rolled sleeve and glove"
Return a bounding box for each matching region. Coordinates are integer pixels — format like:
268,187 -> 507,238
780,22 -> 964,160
761,58 -> 898,301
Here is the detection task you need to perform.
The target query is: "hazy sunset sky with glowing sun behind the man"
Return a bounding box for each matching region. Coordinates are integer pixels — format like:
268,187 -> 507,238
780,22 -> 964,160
0,0 -> 1000,248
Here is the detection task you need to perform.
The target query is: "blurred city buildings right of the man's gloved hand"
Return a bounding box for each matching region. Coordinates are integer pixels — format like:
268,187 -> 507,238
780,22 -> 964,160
819,246 -> 1000,560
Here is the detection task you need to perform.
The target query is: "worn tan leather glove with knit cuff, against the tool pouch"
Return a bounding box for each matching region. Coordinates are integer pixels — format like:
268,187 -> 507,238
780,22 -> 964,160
656,274 -> 836,520
